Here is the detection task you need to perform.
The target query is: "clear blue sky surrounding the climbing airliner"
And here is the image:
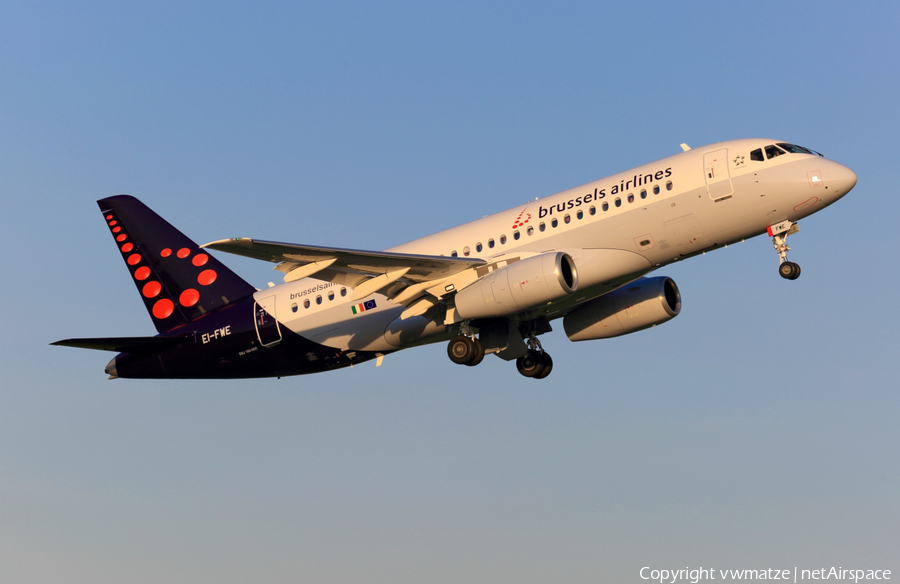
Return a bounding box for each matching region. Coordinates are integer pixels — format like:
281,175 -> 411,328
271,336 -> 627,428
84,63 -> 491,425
0,1 -> 900,583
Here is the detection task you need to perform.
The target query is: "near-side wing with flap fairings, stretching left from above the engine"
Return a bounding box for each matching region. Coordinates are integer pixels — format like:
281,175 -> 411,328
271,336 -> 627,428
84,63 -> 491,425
200,237 -> 486,304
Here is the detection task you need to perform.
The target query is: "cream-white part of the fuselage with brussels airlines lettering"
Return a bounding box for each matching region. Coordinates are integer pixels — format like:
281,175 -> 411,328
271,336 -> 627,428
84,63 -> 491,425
256,139 -> 856,352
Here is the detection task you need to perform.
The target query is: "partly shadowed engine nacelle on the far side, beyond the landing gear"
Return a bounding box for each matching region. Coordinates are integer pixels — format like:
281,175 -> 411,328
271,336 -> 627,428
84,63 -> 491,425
563,277 -> 681,341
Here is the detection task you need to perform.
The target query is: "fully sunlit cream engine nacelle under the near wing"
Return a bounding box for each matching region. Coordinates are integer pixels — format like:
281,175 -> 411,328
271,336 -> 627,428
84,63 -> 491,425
456,251 -> 578,319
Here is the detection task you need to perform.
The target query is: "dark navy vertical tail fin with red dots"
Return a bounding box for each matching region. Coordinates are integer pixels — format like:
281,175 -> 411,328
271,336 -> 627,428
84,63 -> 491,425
97,195 -> 256,333
